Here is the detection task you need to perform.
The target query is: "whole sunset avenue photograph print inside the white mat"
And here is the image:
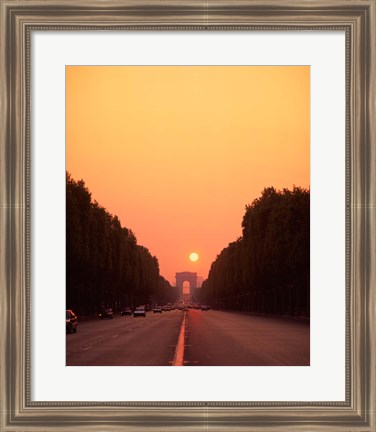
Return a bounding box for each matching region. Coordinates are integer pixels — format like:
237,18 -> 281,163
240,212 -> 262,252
66,65 -> 310,366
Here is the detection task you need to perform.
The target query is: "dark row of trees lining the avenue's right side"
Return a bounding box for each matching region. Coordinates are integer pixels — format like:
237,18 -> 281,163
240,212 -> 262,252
200,187 -> 310,316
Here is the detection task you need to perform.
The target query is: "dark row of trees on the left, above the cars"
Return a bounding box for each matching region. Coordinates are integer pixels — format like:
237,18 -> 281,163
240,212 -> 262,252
66,173 -> 175,315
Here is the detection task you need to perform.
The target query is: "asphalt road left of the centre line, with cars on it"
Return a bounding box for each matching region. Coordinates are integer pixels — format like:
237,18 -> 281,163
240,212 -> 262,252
66,310 -> 183,366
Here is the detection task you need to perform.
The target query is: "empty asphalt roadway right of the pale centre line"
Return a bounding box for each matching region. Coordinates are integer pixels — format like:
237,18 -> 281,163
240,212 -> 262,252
184,310 -> 309,366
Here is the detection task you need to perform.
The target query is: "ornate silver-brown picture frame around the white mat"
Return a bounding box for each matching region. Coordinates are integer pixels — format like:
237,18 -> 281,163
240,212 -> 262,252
0,0 -> 376,432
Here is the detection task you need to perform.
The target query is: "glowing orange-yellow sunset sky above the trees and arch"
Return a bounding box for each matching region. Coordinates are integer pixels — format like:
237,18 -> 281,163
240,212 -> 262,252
66,66 -> 310,285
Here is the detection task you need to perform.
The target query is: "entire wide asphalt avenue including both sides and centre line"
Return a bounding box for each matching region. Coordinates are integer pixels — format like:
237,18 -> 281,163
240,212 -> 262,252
66,309 -> 310,366
